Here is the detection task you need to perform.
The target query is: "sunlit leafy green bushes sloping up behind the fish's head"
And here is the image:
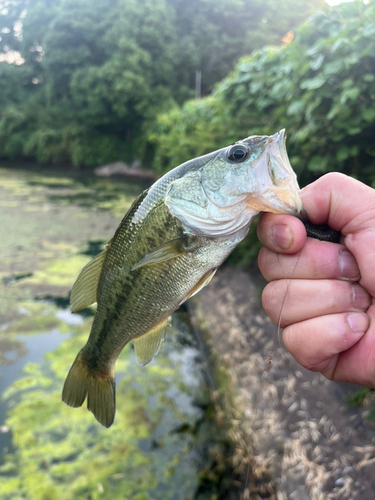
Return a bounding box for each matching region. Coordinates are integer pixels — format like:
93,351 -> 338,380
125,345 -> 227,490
151,1 -> 375,190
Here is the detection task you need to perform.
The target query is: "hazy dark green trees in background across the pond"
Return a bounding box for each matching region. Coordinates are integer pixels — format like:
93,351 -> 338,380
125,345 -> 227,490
0,0 -> 323,165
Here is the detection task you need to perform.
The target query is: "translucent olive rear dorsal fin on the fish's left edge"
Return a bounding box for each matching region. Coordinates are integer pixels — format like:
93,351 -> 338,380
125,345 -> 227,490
70,249 -> 110,313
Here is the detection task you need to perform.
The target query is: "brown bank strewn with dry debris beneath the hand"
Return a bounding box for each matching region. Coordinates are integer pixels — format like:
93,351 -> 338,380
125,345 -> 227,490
192,267 -> 375,500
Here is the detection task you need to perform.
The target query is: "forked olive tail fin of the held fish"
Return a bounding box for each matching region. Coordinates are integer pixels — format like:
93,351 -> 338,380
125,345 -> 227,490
62,350 -> 116,427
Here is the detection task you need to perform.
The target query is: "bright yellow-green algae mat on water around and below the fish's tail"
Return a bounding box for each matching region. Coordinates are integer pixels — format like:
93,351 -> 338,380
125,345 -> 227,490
0,320 -> 206,500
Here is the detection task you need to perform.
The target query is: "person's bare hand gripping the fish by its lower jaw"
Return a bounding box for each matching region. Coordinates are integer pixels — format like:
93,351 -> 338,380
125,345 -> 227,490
258,173 -> 375,388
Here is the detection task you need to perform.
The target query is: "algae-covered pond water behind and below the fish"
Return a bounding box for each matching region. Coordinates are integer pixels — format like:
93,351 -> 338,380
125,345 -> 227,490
0,168 -> 239,500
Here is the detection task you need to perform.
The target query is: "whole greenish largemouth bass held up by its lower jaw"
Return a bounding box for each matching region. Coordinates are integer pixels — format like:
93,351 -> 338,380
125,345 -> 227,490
62,130 -> 304,427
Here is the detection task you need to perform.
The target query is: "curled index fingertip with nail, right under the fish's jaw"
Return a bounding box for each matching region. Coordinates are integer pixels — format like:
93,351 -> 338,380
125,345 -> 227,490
257,213 -> 306,254
